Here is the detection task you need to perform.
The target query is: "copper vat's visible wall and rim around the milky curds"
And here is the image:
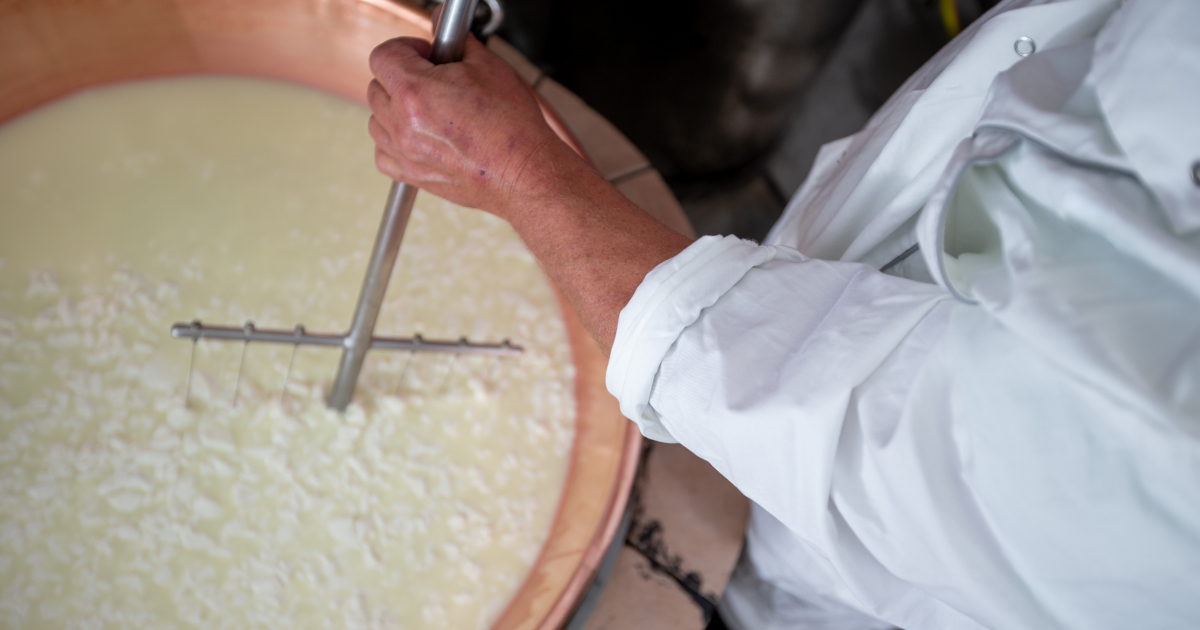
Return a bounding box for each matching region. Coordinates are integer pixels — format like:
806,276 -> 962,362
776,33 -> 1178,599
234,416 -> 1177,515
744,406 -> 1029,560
0,0 -> 641,630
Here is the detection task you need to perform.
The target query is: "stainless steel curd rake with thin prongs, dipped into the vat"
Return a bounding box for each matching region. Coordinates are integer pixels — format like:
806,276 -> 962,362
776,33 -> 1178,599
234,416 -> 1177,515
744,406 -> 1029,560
170,0 -> 522,412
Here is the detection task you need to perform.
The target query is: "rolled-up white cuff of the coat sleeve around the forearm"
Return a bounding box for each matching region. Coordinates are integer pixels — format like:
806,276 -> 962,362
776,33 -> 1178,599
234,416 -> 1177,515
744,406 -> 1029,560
605,231 -> 805,443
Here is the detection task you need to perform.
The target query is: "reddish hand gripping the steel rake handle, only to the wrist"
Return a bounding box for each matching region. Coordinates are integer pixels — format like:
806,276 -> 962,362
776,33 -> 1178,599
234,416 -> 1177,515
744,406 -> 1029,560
367,36 -> 578,218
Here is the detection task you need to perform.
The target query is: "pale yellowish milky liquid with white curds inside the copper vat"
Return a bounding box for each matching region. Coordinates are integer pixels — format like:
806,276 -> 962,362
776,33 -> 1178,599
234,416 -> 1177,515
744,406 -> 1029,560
0,77 -> 575,629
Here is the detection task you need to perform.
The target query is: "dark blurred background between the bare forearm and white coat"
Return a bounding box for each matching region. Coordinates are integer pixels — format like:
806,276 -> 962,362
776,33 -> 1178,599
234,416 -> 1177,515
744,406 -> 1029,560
482,0 -> 997,239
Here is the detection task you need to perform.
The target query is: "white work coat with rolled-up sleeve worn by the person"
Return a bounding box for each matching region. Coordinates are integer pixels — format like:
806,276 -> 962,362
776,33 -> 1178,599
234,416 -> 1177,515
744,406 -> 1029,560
608,0 -> 1200,630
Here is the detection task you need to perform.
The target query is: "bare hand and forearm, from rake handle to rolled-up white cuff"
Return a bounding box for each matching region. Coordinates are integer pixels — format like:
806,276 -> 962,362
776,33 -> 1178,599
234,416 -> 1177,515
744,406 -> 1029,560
367,31 -> 690,354
